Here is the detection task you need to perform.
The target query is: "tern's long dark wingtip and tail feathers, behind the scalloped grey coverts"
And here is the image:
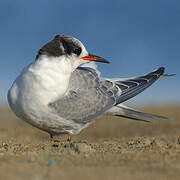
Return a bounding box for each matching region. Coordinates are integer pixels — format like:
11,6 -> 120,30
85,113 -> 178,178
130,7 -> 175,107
104,67 -> 175,122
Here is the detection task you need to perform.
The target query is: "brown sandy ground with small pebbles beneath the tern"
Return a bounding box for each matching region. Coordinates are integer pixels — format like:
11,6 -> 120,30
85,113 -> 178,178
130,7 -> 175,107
0,106 -> 180,180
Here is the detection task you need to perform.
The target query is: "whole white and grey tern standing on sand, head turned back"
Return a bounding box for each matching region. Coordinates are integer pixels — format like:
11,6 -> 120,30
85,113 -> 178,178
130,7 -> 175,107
7,34 -> 174,142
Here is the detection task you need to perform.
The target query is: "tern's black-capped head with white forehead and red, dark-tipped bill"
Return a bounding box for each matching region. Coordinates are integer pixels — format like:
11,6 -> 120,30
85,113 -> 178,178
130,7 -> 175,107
36,35 -> 109,69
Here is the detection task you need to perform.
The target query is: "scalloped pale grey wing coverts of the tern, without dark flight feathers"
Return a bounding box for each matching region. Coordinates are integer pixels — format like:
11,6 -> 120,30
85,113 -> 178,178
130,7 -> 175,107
49,67 -> 118,124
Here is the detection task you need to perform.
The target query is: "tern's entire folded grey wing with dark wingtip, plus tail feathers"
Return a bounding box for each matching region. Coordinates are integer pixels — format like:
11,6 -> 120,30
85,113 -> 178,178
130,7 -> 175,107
49,67 -> 171,124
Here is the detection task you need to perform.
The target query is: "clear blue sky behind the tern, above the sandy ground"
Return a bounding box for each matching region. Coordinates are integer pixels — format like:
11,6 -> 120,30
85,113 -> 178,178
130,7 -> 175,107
0,0 -> 180,104
